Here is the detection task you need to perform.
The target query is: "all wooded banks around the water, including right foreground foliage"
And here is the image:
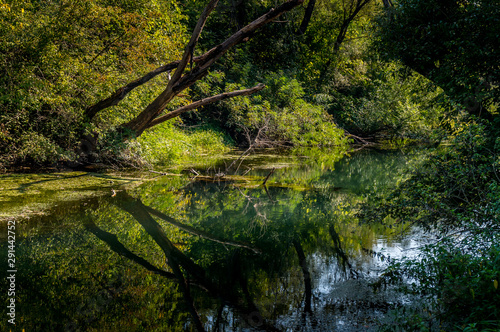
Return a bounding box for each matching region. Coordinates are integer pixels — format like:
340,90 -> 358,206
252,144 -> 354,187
0,0 -> 500,331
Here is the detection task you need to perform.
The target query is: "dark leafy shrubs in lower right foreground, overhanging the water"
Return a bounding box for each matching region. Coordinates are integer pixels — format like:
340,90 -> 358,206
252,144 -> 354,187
360,120 -> 500,330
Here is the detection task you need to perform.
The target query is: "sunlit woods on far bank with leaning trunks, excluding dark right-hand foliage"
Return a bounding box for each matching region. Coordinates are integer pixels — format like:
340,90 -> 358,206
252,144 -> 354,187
0,0 -> 452,167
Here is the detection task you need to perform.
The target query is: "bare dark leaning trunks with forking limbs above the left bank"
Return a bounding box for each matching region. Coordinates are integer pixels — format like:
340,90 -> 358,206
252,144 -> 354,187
81,0 -> 304,152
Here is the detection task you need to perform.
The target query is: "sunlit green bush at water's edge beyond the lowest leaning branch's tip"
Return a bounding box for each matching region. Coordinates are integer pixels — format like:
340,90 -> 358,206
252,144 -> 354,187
185,69 -> 346,146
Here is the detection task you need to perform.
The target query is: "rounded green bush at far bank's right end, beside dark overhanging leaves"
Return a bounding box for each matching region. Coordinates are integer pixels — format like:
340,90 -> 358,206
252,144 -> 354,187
315,63 -> 444,139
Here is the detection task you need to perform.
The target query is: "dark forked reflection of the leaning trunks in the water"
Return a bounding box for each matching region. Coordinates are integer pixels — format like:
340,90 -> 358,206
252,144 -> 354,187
92,192 -> 277,331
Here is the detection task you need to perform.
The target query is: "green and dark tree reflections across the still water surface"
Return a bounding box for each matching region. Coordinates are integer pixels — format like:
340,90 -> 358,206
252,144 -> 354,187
0,152 -> 424,331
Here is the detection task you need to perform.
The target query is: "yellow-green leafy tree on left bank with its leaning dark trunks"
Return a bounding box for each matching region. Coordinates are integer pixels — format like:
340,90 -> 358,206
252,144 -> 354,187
0,0 -> 303,166
